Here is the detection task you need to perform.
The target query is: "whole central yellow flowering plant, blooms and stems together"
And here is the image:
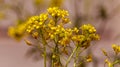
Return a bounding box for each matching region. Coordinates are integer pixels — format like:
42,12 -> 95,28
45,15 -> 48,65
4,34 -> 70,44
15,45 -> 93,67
9,7 -> 99,67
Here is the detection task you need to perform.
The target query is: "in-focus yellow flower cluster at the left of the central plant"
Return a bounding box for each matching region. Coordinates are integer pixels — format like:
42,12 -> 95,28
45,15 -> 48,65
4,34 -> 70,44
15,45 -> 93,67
27,14 -> 48,33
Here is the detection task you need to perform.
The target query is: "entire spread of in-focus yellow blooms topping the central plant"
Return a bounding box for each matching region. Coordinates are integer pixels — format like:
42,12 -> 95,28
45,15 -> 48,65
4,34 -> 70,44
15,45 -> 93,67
26,7 -> 99,48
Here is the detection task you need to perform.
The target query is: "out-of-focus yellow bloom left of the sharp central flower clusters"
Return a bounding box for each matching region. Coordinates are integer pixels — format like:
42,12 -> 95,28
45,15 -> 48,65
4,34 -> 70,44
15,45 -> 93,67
8,23 -> 26,40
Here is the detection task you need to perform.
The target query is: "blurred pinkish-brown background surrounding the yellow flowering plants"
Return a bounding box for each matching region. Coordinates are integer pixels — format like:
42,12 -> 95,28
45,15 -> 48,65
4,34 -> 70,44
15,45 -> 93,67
0,0 -> 120,67
